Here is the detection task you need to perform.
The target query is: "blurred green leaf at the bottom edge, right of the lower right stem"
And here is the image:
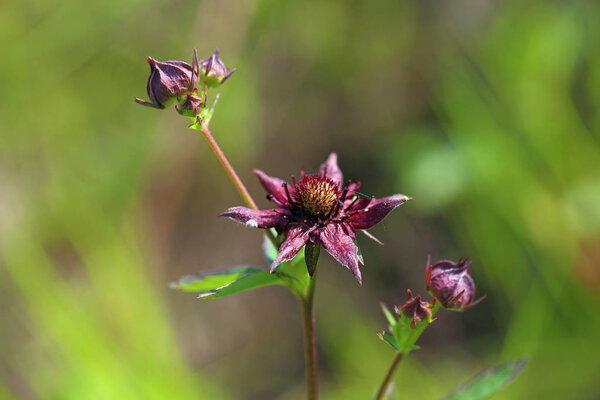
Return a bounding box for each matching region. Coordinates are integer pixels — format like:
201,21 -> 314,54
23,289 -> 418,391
444,359 -> 527,400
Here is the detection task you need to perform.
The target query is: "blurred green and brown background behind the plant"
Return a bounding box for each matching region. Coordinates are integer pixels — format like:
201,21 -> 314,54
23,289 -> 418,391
0,0 -> 600,400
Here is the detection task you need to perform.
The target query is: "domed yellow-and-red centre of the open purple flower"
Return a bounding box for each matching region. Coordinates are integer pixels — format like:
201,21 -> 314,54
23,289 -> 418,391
296,175 -> 339,216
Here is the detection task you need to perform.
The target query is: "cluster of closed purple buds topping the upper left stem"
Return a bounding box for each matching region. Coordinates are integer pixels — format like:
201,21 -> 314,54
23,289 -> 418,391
135,50 -> 236,119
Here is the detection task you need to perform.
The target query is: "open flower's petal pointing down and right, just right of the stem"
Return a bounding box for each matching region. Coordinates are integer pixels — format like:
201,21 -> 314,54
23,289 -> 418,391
321,224 -> 362,284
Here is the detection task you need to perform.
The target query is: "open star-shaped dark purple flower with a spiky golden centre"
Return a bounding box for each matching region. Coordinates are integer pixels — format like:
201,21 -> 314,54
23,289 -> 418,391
222,153 -> 411,283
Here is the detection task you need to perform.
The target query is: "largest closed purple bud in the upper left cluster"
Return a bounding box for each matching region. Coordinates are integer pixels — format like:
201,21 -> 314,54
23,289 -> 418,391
135,50 -> 199,109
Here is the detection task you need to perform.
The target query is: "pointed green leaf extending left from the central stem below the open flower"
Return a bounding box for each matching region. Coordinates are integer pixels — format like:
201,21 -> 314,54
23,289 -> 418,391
170,266 -> 285,299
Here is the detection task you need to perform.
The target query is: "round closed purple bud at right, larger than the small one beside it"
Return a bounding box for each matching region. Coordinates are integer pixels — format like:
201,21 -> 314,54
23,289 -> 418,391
425,255 -> 486,311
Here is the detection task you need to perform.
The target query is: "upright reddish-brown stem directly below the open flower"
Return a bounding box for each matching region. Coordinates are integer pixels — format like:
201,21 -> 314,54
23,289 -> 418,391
302,268 -> 319,400
